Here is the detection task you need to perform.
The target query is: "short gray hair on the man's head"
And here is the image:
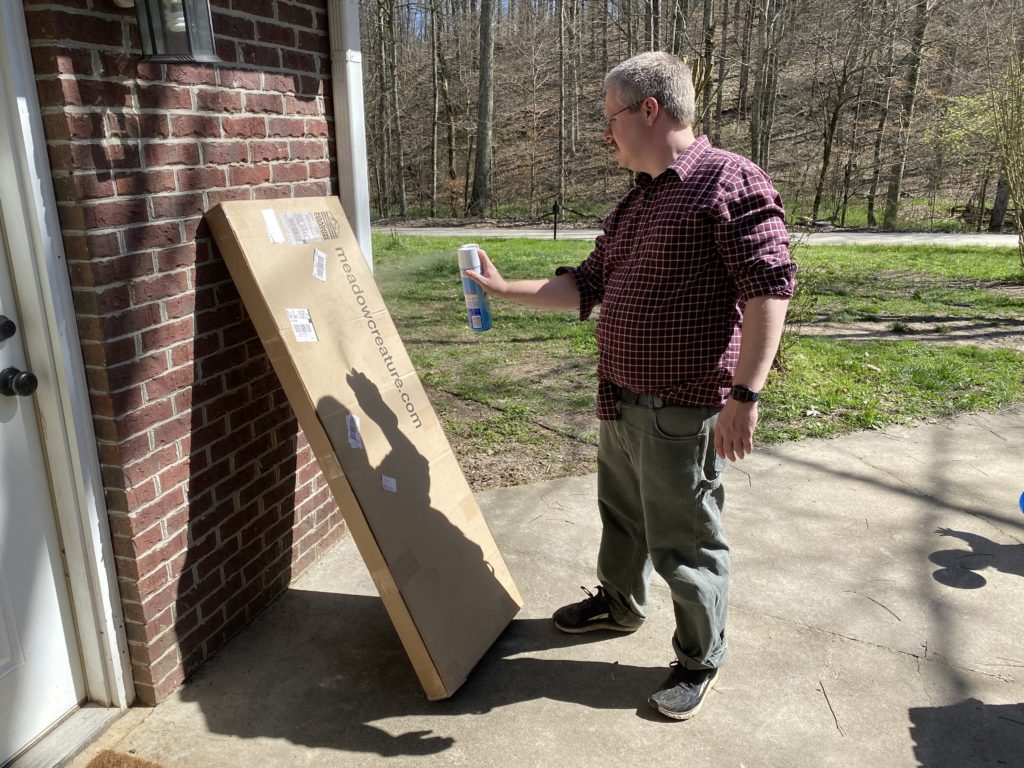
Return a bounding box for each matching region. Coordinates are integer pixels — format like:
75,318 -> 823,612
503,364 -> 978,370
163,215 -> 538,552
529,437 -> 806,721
604,51 -> 696,126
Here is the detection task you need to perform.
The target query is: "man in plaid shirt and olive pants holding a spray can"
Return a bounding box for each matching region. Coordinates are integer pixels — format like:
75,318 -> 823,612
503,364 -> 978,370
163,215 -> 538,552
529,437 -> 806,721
468,52 -> 796,720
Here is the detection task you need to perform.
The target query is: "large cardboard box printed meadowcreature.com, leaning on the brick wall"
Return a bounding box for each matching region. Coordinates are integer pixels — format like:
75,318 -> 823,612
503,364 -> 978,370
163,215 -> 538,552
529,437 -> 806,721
207,198 -> 522,699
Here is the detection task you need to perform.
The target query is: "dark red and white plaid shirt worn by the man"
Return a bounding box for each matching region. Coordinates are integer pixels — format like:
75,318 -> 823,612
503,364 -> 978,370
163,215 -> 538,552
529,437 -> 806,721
556,136 -> 797,420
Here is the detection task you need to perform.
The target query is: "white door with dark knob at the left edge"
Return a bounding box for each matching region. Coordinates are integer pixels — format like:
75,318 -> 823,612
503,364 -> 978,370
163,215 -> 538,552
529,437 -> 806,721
0,207 -> 85,765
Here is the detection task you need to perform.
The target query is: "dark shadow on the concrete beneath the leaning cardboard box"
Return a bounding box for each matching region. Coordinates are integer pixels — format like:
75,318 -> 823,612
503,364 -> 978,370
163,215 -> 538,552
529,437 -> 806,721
180,589 -> 665,757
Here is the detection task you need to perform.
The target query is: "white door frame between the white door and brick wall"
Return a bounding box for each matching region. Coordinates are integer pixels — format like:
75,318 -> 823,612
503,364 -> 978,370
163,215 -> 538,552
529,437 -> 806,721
0,0 -> 134,709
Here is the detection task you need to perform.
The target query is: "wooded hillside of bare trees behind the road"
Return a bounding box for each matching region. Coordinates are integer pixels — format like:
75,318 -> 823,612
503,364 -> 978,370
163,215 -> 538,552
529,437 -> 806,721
361,0 -> 1024,236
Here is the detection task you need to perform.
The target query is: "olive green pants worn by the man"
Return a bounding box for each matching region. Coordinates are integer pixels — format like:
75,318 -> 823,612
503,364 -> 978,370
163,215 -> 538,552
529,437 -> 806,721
597,402 -> 729,670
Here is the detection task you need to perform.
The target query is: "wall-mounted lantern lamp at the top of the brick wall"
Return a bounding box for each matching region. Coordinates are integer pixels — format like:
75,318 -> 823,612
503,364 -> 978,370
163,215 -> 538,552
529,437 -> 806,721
114,0 -> 220,63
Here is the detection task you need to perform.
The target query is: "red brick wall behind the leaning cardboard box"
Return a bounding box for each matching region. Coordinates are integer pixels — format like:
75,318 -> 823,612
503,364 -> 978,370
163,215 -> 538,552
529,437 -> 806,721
25,0 -> 344,703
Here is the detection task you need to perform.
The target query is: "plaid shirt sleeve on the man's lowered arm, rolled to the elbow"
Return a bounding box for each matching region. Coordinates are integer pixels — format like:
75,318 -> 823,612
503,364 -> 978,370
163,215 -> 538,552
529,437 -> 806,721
714,168 -> 797,301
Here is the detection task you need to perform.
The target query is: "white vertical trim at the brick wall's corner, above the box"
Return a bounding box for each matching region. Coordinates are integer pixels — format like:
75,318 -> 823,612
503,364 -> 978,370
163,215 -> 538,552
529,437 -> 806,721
327,0 -> 374,270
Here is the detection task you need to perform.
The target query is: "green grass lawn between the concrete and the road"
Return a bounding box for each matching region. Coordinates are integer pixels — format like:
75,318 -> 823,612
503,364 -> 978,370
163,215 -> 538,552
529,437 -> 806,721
374,234 -> 1024,473
